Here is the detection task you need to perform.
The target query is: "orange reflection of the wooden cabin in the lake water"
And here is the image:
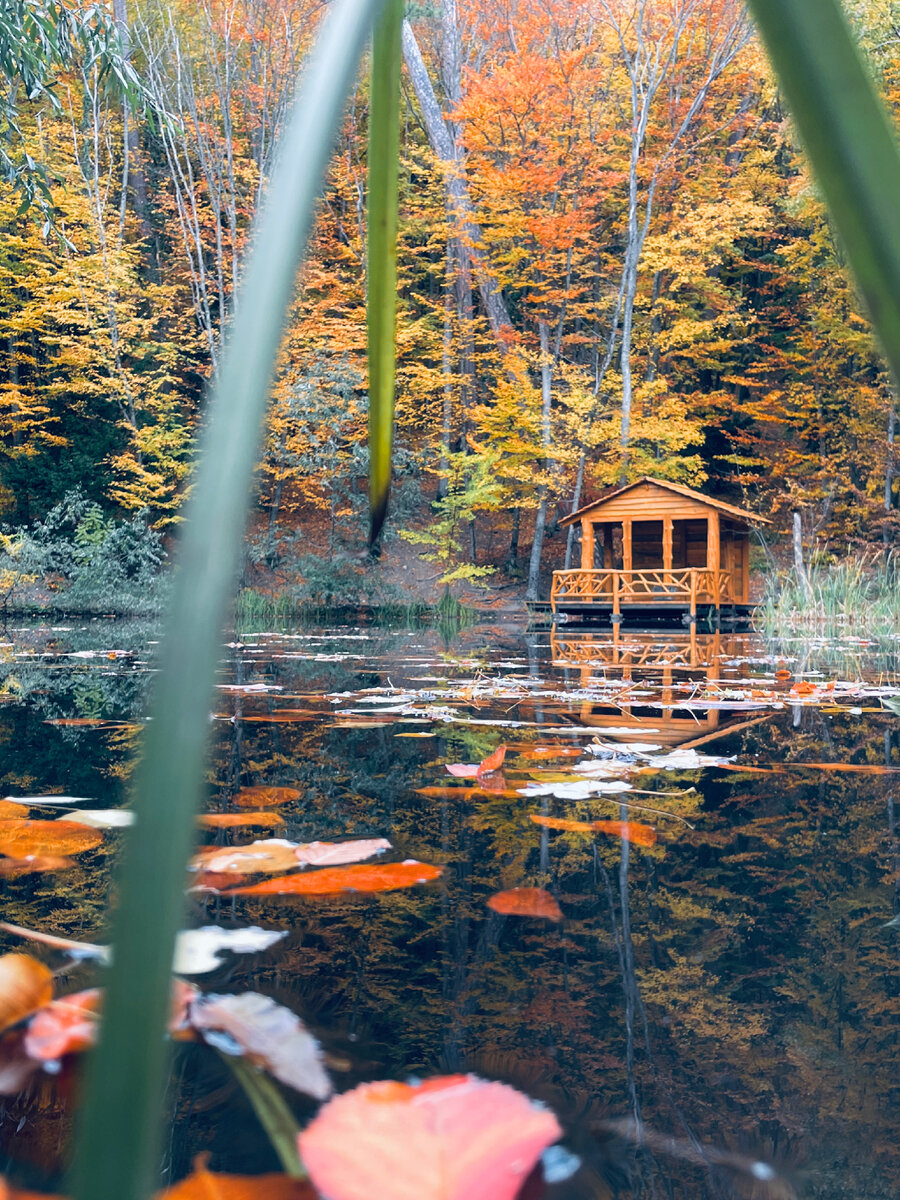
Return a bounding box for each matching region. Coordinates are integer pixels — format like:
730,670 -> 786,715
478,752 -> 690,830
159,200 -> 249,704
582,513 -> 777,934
551,625 -> 772,750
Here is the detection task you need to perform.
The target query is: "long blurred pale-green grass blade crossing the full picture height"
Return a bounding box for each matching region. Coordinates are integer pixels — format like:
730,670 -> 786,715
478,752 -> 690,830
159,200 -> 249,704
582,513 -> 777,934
66,0 -> 379,1200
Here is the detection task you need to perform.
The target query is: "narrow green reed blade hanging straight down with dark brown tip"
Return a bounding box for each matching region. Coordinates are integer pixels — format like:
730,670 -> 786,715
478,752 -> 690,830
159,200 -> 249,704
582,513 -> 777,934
366,0 -> 403,546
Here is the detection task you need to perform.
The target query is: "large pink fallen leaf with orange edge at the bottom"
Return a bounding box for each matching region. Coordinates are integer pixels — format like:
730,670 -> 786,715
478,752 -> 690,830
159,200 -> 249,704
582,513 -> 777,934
298,1075 -> 562,1200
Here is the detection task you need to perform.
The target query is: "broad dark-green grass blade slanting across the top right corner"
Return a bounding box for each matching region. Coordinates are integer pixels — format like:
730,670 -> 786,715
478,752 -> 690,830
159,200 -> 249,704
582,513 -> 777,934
749,0 -> 900,380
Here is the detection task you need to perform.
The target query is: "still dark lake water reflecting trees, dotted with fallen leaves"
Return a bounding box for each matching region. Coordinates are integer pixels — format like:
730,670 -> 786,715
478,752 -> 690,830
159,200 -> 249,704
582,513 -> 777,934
0,622 -> 900,1200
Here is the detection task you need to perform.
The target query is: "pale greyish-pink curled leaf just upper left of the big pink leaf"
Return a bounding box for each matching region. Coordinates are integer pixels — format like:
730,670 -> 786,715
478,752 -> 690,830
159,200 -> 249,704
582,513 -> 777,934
188,991 -> 334,1100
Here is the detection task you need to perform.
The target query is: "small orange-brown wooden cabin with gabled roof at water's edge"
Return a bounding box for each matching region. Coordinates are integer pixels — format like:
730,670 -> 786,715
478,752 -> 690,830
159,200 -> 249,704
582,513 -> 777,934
550,475 -> 769,623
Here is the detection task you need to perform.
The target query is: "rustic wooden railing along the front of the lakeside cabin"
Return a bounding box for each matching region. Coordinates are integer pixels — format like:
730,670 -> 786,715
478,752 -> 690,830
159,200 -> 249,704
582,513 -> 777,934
550,568 -> 734,613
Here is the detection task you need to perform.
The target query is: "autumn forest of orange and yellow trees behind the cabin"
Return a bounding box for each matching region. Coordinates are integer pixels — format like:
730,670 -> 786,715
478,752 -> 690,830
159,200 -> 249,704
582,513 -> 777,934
0,0 -> 900,609
